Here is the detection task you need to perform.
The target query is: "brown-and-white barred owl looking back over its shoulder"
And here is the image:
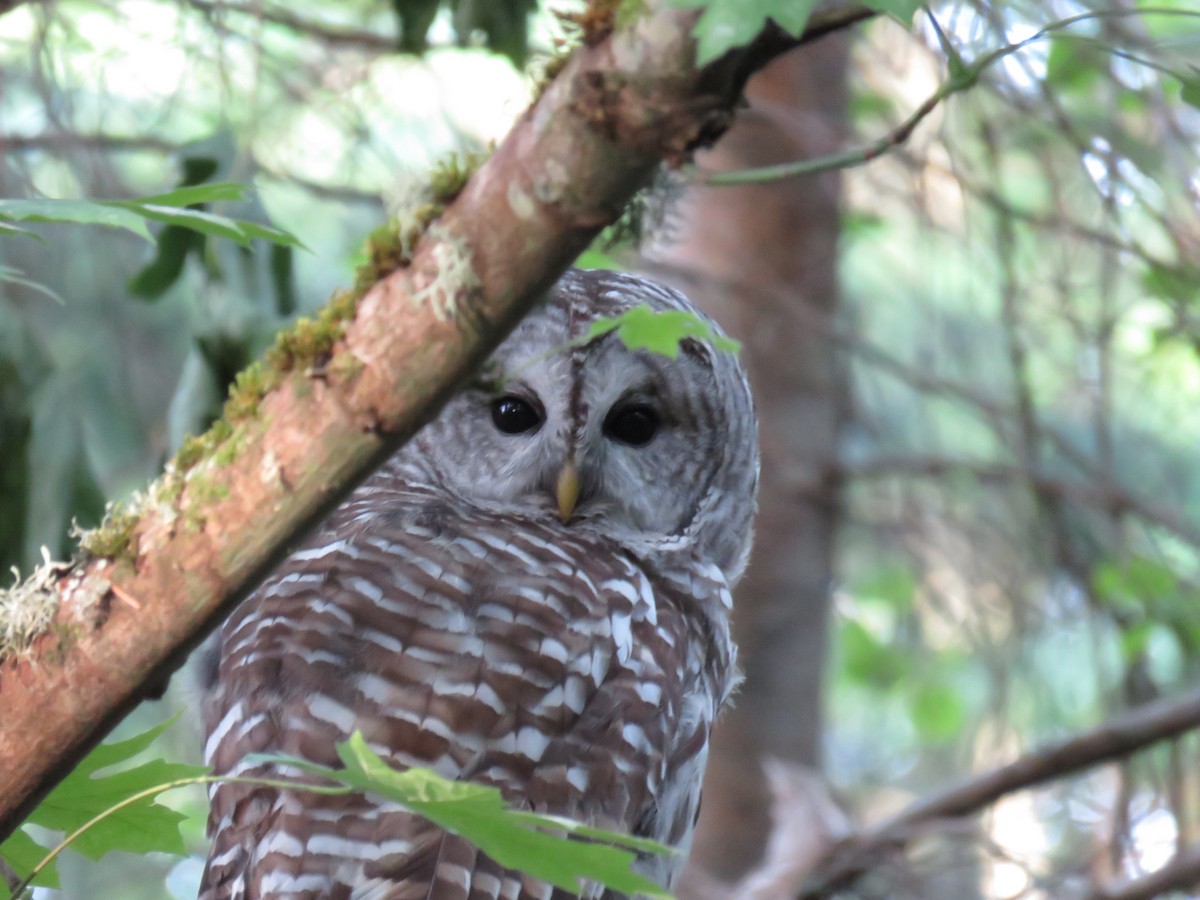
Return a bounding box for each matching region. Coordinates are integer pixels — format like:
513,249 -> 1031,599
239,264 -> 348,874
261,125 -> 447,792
200,270 -> 758,900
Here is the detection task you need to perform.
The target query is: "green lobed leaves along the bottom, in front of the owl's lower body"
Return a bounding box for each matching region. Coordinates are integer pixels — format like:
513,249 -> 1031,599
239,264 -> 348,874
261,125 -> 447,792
0,716 -> 676,899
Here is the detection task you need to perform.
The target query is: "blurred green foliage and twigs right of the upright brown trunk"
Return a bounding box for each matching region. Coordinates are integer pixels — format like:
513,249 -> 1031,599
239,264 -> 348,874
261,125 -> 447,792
826,4 -> 1200,896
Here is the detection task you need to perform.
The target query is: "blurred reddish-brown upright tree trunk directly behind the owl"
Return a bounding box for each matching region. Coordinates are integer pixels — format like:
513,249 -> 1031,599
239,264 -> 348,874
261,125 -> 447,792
653,37 -> 846,882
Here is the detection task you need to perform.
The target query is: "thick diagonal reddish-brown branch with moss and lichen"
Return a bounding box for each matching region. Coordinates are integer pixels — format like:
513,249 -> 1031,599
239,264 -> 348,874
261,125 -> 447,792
0,2 -> 864,839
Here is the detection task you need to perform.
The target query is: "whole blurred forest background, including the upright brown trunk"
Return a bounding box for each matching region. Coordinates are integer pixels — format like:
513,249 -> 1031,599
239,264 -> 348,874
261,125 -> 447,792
0,0 -> 1200,900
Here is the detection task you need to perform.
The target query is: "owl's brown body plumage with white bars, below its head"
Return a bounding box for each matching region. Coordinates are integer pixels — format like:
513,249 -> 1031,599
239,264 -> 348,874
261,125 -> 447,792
200,479 -> 736,900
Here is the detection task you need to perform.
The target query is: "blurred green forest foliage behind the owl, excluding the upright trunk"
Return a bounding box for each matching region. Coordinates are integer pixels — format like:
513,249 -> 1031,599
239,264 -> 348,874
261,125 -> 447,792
0,0 -> 1200,900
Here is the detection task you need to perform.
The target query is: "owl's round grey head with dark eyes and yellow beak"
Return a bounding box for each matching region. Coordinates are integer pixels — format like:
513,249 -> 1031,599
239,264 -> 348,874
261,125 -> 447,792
410,270 -> 758,583
